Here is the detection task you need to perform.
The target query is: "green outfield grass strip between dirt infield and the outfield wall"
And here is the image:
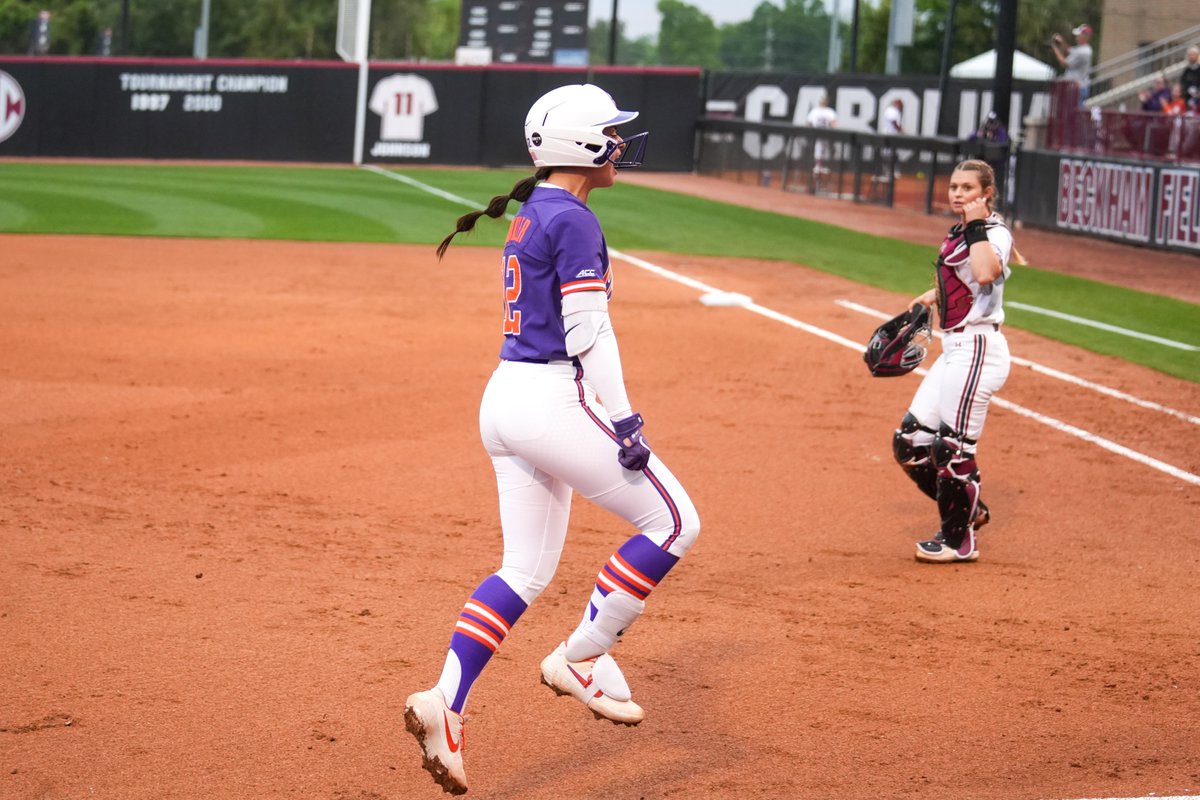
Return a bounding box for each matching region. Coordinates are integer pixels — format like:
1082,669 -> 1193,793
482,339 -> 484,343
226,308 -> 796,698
0,162 -> 1200,383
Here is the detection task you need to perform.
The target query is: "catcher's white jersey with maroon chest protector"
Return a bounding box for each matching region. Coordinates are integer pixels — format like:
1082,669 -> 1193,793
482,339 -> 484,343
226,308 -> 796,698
937,213 -> 1013,331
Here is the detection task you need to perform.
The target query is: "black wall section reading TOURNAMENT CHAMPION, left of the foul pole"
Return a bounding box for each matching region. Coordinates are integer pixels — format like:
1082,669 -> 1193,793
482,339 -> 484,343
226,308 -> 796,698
0,58 -> 354,161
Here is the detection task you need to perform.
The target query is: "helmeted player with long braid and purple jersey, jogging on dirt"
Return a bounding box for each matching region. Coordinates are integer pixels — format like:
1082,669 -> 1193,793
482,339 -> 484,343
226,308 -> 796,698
404,85 -> 700,794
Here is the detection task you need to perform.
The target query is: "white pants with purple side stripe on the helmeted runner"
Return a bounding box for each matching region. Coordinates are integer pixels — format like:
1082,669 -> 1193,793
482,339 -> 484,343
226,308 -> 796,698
479,361 -> 700,603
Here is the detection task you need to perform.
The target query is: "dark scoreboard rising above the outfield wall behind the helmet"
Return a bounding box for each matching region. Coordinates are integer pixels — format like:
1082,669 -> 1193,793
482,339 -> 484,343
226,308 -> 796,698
458,0 -> 588,67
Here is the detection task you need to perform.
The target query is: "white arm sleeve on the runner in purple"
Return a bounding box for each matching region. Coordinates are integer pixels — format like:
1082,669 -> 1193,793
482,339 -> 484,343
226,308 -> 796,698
563,291 -> 634,420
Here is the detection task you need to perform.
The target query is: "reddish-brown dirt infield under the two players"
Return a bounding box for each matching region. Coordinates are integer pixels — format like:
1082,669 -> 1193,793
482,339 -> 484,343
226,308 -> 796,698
0,189 -> 1200,800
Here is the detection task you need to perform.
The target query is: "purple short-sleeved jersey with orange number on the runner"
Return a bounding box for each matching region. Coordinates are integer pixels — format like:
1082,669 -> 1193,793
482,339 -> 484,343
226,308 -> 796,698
500,186 -> 612,361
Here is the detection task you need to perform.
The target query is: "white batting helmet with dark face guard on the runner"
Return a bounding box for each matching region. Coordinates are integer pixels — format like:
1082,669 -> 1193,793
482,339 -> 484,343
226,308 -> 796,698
526,84 -> 649,169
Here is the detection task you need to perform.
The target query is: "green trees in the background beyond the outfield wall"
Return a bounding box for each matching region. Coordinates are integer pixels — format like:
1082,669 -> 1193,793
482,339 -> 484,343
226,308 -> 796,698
0,0 -> 1103,74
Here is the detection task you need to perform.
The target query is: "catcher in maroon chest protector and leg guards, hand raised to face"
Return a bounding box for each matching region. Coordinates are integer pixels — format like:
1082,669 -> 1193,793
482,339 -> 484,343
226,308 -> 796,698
893,161 -> 1025,563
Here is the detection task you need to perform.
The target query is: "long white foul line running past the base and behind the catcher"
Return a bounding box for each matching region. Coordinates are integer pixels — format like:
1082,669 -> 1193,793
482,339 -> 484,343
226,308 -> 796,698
364,166 -> 1200,486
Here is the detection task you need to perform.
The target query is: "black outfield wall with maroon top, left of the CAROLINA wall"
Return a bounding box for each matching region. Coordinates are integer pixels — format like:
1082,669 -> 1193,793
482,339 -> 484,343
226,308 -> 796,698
0,56 -> 702,170
